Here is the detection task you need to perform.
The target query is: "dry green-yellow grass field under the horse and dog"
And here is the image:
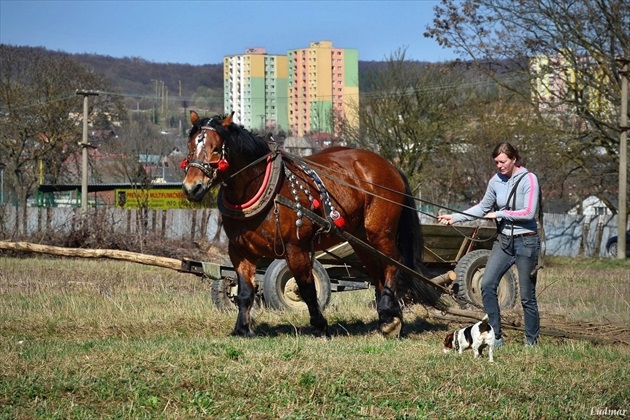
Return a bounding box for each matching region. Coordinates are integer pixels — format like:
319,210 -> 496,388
0,256 -> 630,419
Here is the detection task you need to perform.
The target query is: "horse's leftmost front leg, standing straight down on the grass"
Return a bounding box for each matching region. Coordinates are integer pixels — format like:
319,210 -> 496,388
229,250 -> 256,337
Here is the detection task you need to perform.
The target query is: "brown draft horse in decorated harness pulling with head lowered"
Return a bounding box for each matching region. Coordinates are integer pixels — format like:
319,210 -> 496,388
182,111 -> 439,336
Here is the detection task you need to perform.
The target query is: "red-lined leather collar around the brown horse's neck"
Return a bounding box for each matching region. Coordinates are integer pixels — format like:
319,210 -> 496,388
217,153 -> 282,219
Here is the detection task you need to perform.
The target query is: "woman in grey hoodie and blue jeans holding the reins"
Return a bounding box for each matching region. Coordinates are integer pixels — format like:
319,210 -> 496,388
438,142 -> 540,347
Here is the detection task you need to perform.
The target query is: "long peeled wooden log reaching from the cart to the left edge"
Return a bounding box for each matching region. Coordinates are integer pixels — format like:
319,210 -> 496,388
0,241 -> 182,271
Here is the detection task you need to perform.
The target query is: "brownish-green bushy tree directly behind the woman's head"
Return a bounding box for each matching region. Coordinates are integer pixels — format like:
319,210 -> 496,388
423,97 -> 567,210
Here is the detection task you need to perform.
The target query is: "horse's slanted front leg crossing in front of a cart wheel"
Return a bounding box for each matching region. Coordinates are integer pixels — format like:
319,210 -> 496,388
286,249 -> 330,338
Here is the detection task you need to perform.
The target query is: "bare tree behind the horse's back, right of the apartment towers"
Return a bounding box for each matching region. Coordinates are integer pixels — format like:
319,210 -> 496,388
344,50 -> 472,192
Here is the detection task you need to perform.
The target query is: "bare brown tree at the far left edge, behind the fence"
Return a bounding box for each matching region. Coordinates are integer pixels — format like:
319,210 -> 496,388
0,45 -> 124,231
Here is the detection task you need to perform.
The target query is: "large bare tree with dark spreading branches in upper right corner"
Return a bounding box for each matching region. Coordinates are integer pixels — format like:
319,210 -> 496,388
425,0 -> 630,207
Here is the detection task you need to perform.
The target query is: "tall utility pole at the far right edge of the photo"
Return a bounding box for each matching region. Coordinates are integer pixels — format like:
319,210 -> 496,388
617,58 -> 630,260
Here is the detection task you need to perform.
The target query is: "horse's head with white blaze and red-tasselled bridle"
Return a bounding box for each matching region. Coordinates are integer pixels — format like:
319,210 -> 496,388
181,111 -> 234,201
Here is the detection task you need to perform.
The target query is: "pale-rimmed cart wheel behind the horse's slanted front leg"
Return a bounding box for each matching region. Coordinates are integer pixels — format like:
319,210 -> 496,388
263,260 -> 331,311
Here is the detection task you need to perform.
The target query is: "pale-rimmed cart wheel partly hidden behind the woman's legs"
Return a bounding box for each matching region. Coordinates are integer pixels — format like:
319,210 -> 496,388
453,249 -> 518,309
